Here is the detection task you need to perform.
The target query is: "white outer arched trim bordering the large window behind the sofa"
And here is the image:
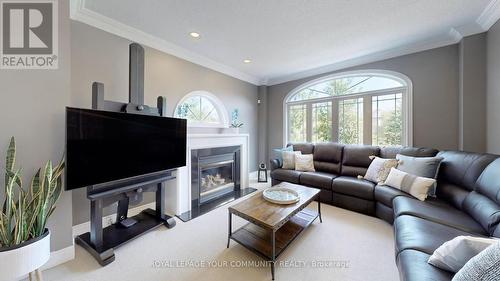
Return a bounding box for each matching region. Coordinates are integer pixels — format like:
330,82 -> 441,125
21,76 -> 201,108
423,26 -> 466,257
283,69 -> 413,146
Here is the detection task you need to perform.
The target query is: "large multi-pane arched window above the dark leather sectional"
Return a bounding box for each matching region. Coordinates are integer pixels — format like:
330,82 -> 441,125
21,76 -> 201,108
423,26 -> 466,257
283,70 -> 413,146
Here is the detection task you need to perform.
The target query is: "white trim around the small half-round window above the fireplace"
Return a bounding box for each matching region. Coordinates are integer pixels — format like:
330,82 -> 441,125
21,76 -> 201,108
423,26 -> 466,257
174,91 -> 229,128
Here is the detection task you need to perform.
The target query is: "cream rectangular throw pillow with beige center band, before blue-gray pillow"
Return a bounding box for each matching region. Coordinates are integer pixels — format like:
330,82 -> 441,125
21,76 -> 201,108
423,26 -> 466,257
384,168 -> 436,201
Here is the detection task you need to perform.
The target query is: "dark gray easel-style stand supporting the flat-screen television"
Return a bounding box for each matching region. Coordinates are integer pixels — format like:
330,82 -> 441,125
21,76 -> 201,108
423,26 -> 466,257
75,43 -> 175,266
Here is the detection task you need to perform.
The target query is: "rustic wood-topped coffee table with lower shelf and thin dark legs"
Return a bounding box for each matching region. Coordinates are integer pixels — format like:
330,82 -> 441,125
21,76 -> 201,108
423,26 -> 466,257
227,183 -> 323,280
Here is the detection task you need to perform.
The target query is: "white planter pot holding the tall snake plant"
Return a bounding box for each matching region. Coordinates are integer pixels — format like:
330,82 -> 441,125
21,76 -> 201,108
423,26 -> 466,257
0,229 -> 50,281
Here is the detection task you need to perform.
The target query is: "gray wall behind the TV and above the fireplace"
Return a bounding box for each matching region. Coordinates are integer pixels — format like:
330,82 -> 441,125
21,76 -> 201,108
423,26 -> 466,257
71,21 -> 258,225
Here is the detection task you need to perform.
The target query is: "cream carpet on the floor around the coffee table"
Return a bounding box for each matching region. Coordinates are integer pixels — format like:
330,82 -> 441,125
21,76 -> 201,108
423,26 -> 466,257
44,180 -> 399,281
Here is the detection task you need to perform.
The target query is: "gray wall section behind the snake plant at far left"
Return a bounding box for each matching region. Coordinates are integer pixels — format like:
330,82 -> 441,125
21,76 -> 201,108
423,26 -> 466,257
0,1 -> 73,251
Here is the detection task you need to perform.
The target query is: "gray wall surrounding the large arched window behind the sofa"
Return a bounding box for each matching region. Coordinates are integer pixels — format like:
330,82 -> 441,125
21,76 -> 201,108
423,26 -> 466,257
267,45 -> 459,155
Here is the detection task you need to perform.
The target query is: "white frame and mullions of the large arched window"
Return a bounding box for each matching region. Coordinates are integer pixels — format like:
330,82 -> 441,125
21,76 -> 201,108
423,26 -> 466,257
283,69 -> 413,146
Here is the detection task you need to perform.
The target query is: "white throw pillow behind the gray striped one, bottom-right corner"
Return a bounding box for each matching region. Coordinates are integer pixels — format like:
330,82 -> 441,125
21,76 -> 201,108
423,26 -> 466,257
428,236 -> 500,272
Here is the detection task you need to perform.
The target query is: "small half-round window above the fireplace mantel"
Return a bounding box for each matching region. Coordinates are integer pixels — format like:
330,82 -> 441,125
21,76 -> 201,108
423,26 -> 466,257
174,91 -> 228,127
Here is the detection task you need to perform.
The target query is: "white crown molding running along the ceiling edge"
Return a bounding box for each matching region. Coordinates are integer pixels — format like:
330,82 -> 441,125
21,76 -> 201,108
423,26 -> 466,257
70,0 -> 500,86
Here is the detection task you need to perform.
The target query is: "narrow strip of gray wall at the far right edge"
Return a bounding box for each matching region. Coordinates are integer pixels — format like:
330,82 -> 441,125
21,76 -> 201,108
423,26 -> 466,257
487,21 -> 500,154
